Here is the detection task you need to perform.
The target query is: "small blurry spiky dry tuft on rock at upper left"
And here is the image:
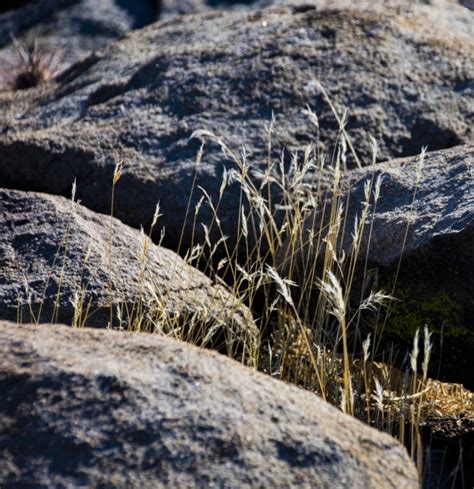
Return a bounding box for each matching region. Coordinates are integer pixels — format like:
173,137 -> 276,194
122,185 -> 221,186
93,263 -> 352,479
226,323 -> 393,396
0,36 -> 64,91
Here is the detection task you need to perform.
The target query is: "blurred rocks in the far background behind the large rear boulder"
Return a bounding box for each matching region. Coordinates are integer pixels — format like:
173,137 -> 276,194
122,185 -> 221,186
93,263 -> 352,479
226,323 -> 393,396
0,0 -> 473,62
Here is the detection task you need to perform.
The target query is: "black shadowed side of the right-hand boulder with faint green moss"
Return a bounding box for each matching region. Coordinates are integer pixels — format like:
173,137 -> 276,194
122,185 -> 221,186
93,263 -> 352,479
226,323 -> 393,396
364,228 -> 474,390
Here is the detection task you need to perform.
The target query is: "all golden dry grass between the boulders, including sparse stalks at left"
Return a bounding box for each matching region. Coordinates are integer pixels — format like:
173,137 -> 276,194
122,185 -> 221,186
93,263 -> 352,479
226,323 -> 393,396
14,83 -> 472,480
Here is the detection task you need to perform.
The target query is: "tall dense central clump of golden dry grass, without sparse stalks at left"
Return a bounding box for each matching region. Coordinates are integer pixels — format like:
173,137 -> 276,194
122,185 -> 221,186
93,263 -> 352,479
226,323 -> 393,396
181,101 -> 466,474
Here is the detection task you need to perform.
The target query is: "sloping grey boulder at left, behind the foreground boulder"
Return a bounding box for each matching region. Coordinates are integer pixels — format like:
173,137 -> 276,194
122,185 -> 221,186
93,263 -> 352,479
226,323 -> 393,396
0,190 -> 255,346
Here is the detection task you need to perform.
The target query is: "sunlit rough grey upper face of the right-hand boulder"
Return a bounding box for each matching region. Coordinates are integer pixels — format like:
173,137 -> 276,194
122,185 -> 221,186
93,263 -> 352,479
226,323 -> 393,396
342,145 -> 474,266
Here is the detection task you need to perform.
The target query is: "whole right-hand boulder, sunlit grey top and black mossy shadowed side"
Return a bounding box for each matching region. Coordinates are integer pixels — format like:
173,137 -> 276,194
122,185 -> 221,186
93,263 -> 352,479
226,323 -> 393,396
290,145 -> 474,389
